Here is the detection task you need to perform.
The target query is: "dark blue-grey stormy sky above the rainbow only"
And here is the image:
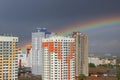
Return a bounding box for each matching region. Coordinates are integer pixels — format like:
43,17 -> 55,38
0,0 -> 120,53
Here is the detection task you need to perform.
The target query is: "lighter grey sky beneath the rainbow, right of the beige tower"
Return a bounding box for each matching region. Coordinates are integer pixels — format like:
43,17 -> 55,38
88,26 -> 120,55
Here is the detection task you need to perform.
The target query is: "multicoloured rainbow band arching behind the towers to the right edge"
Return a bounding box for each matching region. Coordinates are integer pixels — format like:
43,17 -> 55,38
57,16 -> 120,35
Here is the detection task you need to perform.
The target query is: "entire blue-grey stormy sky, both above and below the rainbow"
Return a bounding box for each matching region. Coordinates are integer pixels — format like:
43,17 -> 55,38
0,0 -> 120,54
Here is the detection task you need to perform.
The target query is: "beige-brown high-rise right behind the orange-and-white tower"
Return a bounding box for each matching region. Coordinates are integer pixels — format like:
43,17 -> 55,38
72,32 -> 88,76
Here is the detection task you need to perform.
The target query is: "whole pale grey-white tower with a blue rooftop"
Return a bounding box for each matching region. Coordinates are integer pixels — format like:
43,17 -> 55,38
32,28 -> 51,76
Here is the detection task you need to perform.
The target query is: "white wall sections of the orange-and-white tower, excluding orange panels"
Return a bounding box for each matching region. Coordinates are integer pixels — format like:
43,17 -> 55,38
42,36 -> 75,80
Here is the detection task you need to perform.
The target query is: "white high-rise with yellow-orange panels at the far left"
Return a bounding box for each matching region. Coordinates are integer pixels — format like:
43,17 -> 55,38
0,35 -> 18,80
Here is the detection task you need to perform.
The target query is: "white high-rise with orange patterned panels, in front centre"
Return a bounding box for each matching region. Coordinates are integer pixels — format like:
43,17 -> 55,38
42,36 -> 75,80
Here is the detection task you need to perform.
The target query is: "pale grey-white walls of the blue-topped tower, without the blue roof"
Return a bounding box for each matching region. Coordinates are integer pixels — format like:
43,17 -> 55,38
32,32 -> 45,75
